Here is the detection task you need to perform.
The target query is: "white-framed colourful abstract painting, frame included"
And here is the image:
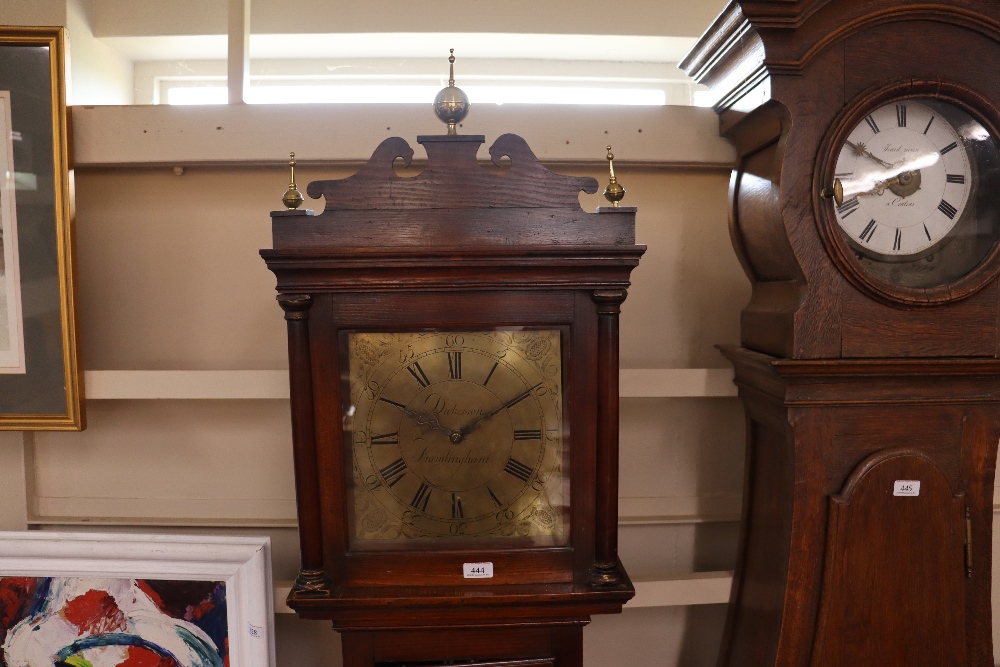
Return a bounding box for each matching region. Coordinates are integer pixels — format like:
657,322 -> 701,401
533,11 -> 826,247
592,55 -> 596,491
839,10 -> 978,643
0,531 -> 274,667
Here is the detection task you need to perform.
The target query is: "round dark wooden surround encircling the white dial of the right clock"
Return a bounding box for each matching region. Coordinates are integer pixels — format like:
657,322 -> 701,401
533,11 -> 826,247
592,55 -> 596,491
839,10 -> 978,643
812,80 -> 1000,307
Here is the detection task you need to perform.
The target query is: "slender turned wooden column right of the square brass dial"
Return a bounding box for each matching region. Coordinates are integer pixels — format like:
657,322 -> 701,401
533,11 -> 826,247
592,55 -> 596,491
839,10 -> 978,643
591,290 -> 628,585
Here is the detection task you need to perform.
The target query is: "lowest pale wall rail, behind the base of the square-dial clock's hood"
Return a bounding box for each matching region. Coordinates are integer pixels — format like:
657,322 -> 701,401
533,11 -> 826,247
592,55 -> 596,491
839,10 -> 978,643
274,571 -> 733,614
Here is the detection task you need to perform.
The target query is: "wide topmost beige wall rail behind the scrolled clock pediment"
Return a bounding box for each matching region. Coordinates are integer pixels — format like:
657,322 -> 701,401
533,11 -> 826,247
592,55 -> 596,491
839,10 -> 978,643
70,104 -> 736,171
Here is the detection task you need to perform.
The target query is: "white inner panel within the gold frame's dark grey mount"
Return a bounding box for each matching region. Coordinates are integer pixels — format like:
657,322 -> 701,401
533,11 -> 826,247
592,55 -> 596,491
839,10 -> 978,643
0,90 -> 26,374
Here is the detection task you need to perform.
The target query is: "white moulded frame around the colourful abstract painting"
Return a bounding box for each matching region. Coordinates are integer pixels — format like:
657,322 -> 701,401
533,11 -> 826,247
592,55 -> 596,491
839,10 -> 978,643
0,531 -> 275,667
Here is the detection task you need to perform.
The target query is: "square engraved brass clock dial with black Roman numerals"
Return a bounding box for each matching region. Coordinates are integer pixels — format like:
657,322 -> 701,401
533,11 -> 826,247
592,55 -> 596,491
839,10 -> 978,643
345,330 -> 569,544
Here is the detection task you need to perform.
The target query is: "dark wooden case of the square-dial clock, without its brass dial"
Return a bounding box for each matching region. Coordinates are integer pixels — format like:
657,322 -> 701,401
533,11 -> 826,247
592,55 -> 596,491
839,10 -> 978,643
261,134 -> 645,666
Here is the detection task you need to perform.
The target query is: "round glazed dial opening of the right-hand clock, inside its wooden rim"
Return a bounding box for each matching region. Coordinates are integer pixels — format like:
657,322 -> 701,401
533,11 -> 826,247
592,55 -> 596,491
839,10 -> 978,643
820,95 -> 1000,304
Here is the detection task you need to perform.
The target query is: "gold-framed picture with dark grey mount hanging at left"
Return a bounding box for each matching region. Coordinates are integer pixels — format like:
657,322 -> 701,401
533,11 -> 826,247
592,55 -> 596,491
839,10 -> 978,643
0,27 -> 85,430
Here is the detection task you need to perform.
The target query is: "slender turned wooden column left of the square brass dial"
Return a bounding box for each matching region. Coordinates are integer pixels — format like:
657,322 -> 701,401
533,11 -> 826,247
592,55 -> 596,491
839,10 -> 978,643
277,294 -> 330,593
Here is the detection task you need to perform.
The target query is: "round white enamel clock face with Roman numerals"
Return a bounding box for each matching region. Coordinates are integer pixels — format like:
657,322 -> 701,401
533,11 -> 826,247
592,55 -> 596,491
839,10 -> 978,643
834,99 -> 973,258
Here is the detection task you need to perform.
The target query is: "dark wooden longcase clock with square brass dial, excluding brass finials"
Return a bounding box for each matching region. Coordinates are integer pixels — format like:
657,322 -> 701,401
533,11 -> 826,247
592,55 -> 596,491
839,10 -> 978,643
261,135 -> 644,667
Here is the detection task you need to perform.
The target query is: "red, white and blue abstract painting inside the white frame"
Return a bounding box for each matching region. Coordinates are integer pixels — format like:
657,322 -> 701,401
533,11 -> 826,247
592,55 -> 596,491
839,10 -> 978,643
0,577 -> 230,667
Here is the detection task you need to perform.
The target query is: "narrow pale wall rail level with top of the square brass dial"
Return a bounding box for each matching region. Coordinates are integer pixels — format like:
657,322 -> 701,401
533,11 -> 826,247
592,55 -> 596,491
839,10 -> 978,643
84,368 -> 736,400
